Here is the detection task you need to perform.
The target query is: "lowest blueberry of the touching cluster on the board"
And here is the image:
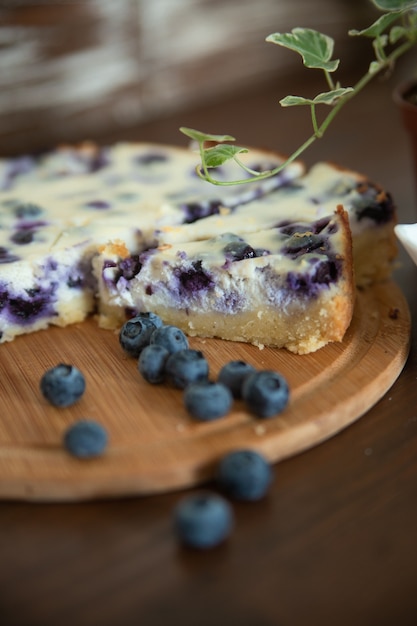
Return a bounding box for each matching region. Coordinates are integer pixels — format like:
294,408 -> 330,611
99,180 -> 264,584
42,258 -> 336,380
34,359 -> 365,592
184,381 -> 233,422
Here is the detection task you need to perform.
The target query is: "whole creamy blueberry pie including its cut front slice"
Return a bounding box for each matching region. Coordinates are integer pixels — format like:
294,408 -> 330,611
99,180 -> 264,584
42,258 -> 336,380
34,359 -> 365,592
0,143 -> 396,352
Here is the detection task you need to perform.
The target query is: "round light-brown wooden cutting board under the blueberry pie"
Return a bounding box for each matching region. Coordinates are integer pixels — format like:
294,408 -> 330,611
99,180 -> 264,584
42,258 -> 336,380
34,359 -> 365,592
0,282 -> 410,501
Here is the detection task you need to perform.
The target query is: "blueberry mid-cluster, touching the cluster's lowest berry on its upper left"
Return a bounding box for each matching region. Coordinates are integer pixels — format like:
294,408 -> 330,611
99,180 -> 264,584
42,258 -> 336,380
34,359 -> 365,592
165,348 -> 209,389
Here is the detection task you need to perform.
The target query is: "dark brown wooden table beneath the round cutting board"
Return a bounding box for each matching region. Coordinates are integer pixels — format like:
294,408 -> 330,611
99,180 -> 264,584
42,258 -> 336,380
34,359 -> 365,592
0,64 -> 417,626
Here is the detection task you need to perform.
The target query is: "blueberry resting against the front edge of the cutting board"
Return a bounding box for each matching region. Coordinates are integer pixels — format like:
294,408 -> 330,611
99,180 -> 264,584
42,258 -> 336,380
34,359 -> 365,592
217,450 -> 272,501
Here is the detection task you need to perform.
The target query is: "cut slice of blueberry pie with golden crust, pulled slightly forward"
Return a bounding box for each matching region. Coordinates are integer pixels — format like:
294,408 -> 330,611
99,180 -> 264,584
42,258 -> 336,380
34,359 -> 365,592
94,208 -> 355,354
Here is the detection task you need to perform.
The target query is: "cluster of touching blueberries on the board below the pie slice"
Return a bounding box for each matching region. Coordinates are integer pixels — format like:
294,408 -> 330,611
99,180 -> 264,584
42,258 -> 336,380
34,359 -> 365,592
119,313 -> 289,421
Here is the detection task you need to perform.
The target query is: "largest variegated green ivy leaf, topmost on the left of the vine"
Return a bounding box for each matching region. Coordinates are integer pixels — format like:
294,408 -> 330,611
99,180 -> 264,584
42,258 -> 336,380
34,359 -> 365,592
266,28 -> 339,72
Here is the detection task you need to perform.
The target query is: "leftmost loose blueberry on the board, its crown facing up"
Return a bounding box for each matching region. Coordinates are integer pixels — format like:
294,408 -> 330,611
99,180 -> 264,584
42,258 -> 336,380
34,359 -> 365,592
40,363 -> 85,407
